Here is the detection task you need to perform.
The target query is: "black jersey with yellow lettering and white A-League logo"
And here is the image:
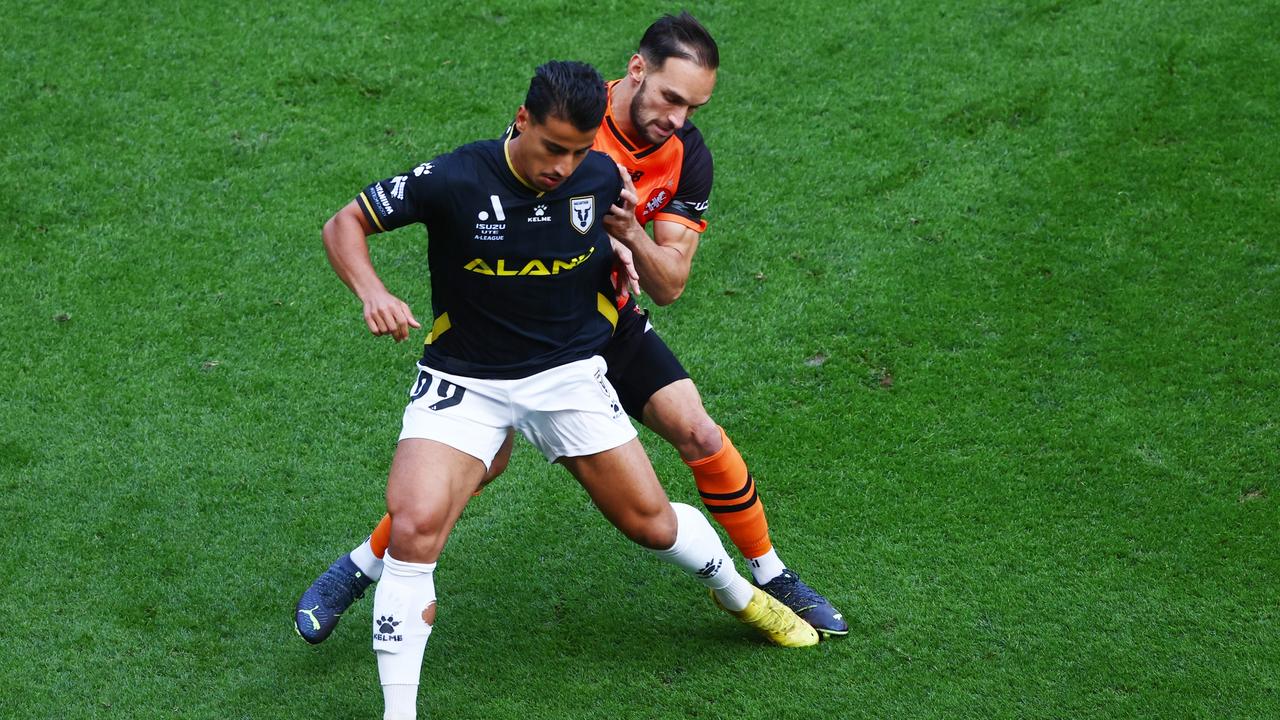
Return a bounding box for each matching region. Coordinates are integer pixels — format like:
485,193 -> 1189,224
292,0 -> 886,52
357,140 -> 622,379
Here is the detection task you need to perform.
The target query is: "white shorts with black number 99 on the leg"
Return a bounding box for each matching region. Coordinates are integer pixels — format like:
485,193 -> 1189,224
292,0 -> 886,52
401,356 -> 636,468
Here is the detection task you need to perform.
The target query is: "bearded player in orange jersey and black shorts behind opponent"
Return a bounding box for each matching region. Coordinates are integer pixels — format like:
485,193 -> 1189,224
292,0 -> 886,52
294,13 -> 849,643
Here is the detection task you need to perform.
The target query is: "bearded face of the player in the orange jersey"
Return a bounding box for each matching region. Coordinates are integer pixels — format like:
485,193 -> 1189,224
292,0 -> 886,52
628,58 -> 716,145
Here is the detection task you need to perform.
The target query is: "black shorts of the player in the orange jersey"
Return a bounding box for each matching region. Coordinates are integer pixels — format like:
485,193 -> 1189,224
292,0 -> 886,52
600,300 -> 689,423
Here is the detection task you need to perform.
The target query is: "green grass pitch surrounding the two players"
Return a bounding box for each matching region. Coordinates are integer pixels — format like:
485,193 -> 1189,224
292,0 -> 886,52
0,0 -> 1280,720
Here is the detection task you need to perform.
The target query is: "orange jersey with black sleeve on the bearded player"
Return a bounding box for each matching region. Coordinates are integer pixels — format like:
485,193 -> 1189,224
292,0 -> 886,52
591,81 -> 712,232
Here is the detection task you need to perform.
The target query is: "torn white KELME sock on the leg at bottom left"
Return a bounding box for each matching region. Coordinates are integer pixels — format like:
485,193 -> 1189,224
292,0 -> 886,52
372,552 -> 435,720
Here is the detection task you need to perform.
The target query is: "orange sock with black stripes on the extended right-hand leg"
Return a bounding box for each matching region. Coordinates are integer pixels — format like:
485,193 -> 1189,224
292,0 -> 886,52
685,428 -> 773,560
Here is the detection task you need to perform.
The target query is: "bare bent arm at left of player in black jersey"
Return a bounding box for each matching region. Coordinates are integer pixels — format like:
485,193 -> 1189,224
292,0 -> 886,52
321,200 -> 422,342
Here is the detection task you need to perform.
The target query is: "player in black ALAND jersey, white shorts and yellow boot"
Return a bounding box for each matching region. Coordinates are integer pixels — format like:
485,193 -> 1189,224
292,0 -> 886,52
324,61 -> 818,719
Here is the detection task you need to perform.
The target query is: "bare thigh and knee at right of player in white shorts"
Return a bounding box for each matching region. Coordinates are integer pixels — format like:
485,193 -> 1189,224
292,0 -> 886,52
559,438 -> 676,550
